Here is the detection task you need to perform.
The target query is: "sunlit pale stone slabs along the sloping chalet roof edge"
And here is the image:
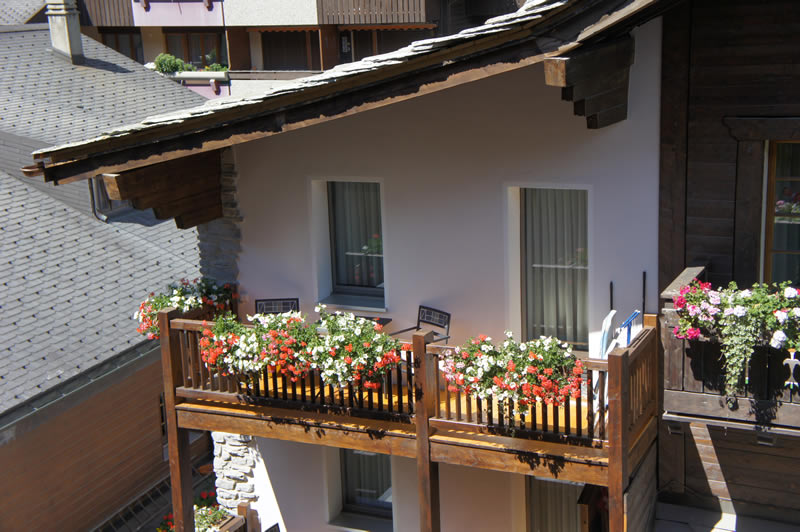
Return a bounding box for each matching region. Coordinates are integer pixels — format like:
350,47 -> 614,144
37,0 -> 579,153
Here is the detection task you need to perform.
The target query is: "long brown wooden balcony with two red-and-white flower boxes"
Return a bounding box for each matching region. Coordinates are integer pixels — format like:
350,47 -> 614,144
160,311 -> 658,530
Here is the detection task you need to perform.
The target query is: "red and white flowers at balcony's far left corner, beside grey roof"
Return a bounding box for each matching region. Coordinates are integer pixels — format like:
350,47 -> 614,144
133,278 -> 239,340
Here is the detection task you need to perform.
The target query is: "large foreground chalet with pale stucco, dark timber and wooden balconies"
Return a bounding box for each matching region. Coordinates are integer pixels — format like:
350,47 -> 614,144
20,0 -> 800,531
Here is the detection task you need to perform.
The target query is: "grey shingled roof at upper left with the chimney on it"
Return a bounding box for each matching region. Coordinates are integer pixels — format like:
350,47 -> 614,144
0,24 -> 206,144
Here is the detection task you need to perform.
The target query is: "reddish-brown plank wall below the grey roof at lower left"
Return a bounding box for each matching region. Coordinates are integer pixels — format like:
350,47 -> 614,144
0,360 -> 209,530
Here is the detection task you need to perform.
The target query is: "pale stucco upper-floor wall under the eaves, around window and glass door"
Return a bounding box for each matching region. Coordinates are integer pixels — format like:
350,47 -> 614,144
231,20 -> 660,356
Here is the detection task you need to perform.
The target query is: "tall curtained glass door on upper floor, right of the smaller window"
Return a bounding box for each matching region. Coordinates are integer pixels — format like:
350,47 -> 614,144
520,188 -> 589,349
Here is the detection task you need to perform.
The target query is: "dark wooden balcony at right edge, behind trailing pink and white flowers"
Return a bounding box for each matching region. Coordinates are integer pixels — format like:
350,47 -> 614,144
661,267 -> 800,436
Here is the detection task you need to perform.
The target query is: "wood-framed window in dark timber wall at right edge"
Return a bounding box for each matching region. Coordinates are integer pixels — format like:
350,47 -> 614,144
764,142 -> 800,283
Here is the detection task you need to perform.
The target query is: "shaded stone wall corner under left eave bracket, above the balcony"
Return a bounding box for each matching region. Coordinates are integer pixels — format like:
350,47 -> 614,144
197,148 -> 242,283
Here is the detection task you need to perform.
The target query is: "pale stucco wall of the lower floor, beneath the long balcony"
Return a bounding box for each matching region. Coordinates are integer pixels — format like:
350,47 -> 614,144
252,438 -> 526,532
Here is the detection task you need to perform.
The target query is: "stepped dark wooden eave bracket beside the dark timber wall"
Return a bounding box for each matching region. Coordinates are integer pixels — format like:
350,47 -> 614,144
544,35 -> 634,129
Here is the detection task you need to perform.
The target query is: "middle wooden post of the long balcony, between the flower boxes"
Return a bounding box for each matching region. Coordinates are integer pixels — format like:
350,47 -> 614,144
413,331 -> 440,532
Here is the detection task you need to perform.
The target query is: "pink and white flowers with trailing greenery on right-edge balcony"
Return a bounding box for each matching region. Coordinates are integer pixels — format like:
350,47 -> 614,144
673,279 -> 800,395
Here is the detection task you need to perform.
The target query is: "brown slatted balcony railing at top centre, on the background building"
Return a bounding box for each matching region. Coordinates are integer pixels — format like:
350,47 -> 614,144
320,0 -> 430,25
